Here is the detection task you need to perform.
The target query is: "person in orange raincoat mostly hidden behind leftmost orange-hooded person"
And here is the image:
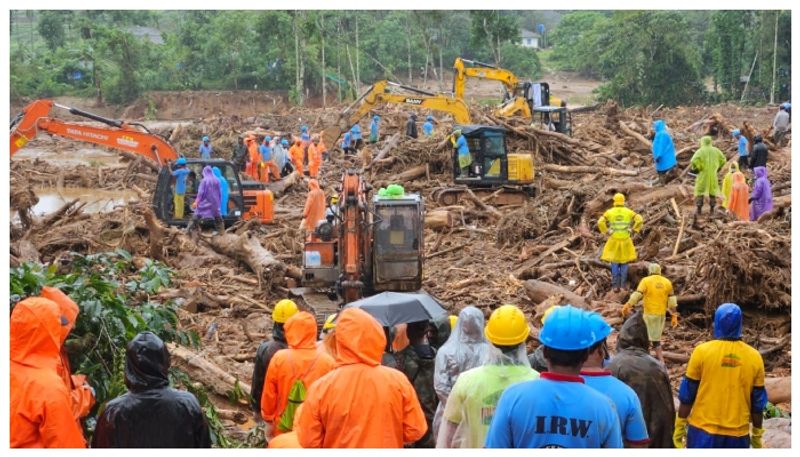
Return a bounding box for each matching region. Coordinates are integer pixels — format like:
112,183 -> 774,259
39,286 -> 94,425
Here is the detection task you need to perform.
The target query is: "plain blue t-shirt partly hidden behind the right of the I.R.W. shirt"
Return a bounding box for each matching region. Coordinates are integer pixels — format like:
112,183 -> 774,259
581,371 -> 650,444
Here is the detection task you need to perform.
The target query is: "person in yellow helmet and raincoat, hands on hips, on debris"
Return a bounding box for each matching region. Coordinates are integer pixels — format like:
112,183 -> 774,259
597,193 -> 644,292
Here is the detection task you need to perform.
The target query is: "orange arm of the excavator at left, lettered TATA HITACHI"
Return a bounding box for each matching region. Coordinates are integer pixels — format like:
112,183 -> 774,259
11,100 -> 178,165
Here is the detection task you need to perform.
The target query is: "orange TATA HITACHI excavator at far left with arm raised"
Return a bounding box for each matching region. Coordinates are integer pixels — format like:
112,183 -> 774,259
10,100 -> 273,226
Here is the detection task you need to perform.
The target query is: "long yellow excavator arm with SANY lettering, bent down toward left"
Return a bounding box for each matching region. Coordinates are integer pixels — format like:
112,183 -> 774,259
322,80 -> 470,146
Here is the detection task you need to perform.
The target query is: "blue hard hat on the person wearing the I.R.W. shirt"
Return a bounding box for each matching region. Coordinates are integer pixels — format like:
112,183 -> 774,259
539,305 -> 598,351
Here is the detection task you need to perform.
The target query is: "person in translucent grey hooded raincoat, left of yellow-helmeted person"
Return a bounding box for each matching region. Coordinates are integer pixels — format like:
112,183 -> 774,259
433,306 -> 491,439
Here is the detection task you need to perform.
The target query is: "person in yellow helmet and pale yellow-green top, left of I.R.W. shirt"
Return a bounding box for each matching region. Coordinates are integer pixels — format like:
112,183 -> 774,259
436,305 -> 539,448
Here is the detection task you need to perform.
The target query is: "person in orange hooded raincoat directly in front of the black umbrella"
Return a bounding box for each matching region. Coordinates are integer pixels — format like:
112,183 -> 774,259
297,308 -> 428,448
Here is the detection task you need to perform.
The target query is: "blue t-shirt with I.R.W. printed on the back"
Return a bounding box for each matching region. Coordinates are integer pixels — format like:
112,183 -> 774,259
486,372 -> 622,448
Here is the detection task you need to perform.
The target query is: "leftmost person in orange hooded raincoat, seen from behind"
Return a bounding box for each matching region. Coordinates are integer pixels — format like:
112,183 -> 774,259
9,297 -> 86,448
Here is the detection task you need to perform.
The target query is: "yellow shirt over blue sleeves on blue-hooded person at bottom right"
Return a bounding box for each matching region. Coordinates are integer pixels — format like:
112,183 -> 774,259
686,340 -> 764,436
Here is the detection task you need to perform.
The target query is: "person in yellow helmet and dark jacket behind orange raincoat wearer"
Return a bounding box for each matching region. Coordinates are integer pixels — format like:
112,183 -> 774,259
250,298 -> 298,422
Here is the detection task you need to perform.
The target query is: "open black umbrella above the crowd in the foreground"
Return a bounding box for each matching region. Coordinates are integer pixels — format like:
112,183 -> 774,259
345,292 -> 447,327
